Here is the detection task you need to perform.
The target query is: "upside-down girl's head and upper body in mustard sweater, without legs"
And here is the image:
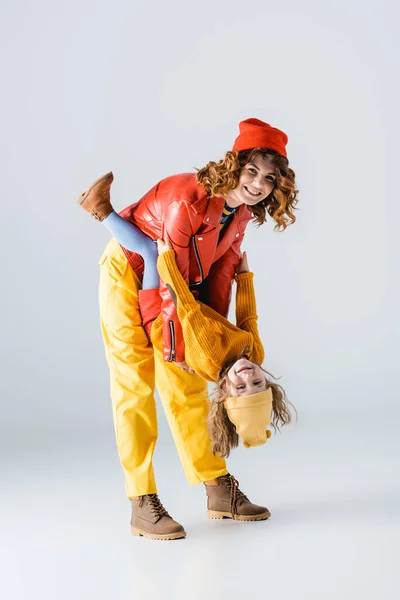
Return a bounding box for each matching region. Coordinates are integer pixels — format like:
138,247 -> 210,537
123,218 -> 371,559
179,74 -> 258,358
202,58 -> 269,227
156,240 -> 291,457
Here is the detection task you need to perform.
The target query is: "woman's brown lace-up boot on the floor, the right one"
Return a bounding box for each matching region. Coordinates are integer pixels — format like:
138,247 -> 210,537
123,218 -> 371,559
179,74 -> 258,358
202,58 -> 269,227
206,473 -> 271,521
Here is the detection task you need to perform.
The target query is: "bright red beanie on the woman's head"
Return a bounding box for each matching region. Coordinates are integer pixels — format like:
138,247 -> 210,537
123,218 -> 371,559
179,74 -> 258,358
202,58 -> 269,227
232,119 -> 288,156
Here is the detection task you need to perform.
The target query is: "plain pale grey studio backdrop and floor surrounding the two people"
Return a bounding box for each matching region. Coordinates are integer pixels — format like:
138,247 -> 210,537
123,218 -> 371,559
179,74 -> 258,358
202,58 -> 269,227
0,0 -> 400,600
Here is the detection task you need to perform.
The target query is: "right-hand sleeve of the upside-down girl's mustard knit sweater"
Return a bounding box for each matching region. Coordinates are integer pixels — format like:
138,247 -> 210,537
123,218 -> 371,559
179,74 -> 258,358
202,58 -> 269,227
236,273 -> 264,364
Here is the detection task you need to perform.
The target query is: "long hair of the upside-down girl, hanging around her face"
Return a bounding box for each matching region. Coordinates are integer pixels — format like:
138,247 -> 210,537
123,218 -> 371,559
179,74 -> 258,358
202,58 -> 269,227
207,348 -> 297,458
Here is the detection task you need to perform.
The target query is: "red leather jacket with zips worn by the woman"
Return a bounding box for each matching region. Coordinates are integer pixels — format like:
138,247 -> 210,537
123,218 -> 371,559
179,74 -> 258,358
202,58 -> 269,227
119,173 -> 252,362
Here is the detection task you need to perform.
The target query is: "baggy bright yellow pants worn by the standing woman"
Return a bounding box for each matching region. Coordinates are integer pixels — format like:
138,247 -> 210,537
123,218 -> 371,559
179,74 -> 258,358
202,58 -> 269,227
99,239 -> 227,497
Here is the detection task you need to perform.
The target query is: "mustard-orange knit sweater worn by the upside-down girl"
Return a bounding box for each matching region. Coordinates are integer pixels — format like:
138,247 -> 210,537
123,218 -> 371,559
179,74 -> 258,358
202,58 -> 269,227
151,250 -> 264,381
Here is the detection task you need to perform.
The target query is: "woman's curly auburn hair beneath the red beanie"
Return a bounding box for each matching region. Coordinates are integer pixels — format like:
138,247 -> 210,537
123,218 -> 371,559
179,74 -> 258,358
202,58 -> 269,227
196,148 -> 298,231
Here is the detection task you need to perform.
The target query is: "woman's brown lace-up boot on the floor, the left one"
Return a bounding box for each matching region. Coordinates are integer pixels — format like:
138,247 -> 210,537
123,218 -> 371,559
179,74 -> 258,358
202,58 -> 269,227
131,494 -> 186,540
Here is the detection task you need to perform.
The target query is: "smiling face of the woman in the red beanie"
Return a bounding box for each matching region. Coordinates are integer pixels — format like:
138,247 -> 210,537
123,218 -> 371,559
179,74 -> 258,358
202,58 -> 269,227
226,154 -> 276,208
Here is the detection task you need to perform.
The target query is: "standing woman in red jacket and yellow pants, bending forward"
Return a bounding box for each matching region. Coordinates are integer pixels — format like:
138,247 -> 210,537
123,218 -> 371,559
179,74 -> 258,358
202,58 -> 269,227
79,119 -> 297,539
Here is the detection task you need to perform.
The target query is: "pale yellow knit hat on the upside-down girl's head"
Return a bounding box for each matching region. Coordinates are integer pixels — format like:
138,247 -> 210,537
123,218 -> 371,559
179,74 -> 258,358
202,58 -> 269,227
224,388 -> 272,448
